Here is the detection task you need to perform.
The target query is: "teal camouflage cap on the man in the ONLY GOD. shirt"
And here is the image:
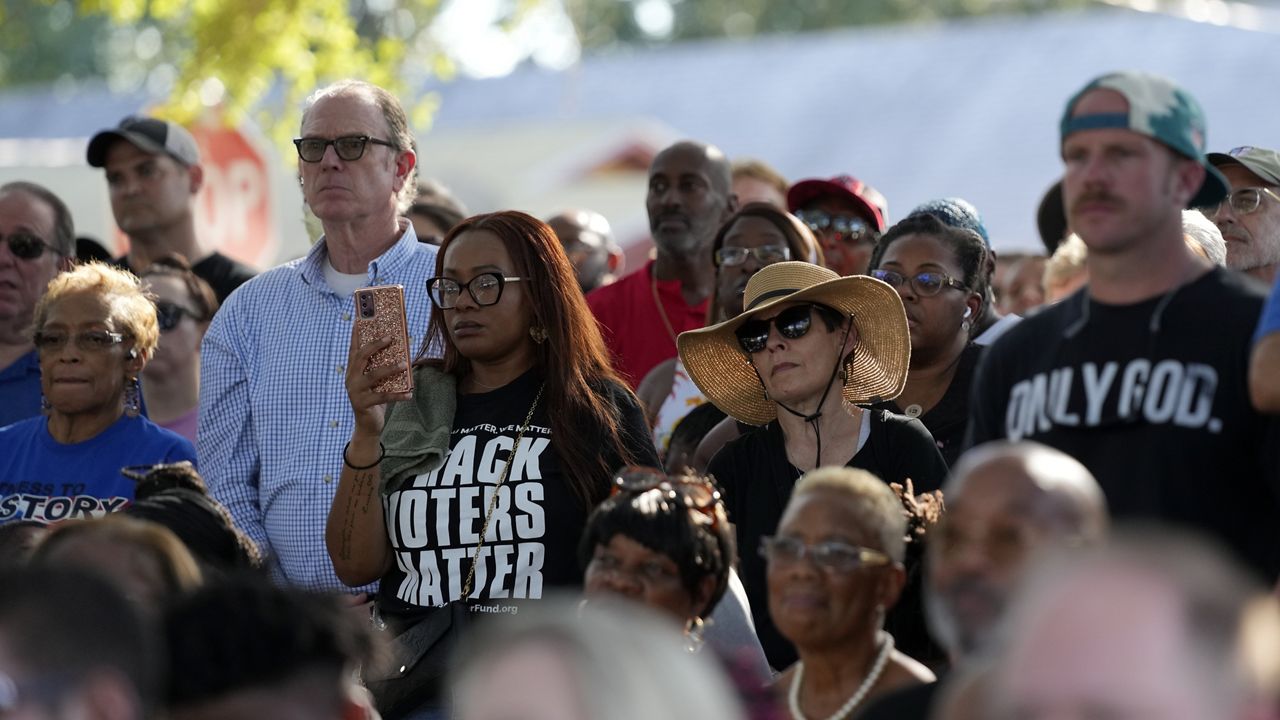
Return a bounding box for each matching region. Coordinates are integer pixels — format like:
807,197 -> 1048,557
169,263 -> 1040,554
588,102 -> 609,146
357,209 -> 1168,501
1061,72 -> 1229,208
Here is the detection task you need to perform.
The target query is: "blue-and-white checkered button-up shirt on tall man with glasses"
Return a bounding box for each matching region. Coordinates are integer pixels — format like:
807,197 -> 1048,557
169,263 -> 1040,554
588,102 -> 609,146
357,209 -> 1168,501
196,227 -> 435,591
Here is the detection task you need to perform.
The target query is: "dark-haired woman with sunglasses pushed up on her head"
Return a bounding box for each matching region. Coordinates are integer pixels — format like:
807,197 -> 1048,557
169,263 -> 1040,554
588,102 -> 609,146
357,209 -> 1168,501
577,468 -> 772,685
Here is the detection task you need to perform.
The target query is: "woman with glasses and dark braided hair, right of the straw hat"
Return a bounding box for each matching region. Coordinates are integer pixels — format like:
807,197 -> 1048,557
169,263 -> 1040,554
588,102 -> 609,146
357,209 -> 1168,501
869,213 -> 987,465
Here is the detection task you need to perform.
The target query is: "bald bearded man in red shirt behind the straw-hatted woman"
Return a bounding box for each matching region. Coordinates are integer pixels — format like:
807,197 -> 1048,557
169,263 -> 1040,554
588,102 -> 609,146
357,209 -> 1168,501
586,141 -> 737,387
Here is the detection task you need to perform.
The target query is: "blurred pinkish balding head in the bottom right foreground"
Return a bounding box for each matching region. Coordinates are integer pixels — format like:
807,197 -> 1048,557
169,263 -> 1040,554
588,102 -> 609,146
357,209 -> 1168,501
980,529 -> 1262,720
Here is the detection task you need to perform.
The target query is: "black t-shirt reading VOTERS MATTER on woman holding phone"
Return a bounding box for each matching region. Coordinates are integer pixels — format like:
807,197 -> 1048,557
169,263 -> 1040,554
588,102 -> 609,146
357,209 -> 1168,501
379,370 -> 658,615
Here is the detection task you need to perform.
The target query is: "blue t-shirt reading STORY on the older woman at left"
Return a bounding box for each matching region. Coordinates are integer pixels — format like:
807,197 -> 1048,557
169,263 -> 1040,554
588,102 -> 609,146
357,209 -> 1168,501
0,415 -> 196,523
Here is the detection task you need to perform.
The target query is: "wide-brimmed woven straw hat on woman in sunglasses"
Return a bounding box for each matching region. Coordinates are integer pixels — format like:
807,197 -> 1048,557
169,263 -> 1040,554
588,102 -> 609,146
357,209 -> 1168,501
677,261 -> 911,425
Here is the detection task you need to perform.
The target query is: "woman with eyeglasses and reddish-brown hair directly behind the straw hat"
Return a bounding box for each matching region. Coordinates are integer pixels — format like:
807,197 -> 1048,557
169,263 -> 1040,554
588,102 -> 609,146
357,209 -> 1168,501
636,202 -> 823,470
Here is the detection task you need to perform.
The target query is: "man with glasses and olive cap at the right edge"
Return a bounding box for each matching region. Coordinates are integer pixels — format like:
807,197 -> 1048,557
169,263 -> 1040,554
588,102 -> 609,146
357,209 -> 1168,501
1204,146 -> 1280,283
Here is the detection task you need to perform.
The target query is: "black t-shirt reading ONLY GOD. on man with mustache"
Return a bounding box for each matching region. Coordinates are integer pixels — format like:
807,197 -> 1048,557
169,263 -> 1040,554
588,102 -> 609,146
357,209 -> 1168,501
969,268 -> 1280,579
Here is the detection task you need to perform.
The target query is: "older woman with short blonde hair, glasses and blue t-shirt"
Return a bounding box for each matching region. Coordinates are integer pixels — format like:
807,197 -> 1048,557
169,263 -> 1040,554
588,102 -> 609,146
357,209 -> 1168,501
0,263 -> 196,523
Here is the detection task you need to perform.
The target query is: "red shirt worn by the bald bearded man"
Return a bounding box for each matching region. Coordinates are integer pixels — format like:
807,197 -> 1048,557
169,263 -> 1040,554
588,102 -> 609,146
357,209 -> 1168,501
586,260 -> 709,388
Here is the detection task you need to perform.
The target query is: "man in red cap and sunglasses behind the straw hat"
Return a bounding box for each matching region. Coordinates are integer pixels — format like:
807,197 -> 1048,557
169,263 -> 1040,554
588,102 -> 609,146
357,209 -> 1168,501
787,176 -> 888,275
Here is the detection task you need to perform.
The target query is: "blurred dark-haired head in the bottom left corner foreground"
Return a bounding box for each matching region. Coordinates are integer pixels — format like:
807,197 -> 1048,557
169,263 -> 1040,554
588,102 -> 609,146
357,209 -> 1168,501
0,568 -> 158,720
